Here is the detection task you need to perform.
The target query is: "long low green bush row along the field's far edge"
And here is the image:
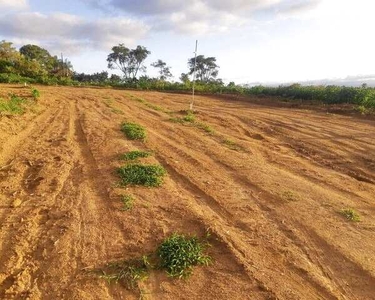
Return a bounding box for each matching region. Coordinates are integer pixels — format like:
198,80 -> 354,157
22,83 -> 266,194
0,73 -> 375,108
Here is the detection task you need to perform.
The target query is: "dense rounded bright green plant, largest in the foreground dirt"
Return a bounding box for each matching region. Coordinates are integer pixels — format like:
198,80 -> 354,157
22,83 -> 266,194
157,234 -> 211,278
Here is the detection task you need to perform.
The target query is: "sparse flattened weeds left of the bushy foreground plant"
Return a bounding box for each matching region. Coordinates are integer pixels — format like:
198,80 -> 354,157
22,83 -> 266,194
100,256 -> 150,289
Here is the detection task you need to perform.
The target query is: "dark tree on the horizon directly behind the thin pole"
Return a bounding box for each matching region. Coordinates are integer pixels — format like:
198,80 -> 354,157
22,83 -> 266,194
188,55 -> 219,83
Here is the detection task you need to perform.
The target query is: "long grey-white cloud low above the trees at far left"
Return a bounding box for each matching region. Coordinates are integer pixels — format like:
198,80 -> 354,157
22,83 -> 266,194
0,12 -> 149,54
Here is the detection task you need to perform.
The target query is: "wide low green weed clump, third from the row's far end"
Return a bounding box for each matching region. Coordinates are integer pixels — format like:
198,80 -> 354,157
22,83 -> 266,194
117,164 -> 166,187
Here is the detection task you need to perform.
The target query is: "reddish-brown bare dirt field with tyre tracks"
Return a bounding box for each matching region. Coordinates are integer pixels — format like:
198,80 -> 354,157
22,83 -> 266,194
0,85 -> 375,300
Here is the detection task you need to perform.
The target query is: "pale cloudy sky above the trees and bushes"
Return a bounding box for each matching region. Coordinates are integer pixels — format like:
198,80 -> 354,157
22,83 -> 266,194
0,0 -> 375,83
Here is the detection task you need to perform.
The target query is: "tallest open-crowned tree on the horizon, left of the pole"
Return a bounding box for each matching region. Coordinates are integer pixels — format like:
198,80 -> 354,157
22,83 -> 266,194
107,44 -> 151,81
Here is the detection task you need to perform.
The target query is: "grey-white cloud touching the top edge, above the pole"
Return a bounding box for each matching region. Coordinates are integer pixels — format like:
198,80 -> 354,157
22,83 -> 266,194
82,0 -> 320,35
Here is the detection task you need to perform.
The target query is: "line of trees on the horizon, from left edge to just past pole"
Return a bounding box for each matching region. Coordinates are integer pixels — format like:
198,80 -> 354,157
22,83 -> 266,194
0,40 -> 223,84
